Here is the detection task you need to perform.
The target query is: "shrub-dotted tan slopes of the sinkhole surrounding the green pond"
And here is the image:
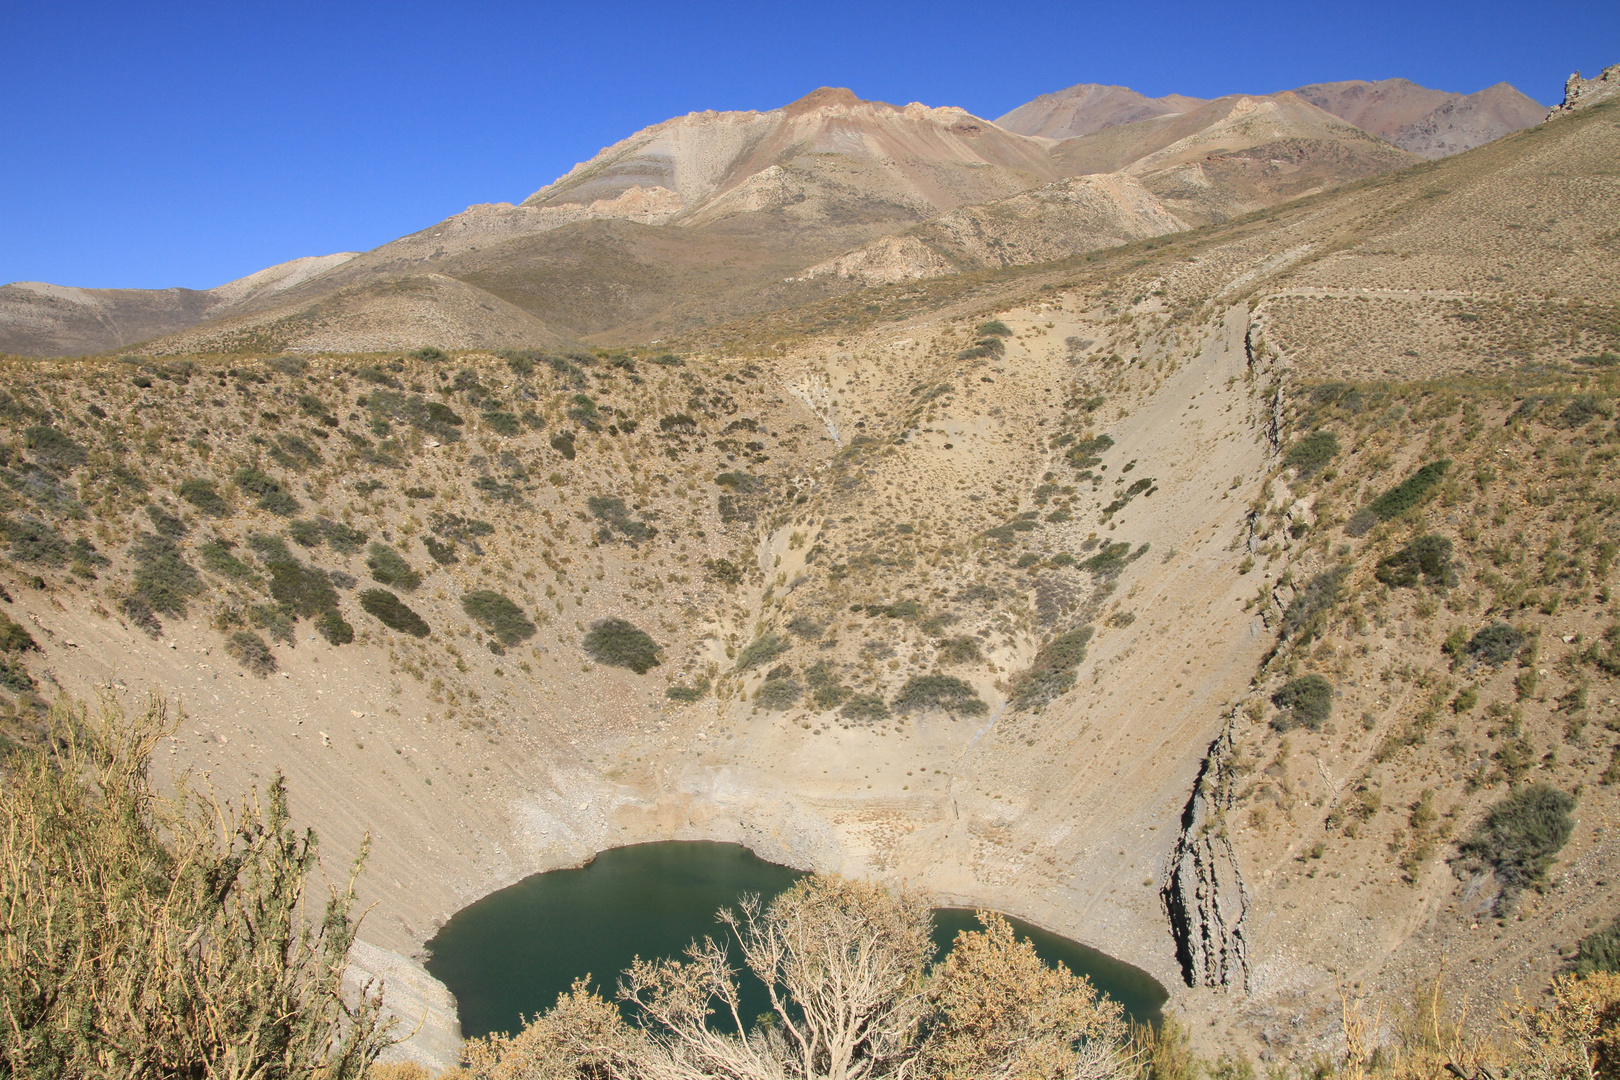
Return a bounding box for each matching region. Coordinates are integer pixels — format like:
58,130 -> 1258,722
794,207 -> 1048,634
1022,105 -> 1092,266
0,76 -> 1620,1061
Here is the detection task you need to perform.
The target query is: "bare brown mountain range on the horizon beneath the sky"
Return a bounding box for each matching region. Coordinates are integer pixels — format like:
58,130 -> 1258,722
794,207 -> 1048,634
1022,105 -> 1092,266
0,81 -> 1528,362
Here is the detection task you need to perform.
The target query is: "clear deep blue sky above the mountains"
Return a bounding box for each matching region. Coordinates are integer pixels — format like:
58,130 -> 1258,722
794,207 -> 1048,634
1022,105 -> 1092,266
0,0 -> 1620,288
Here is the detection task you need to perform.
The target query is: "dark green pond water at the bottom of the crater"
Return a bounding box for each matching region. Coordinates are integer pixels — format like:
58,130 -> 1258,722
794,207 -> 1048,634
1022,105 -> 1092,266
428,840 -> 1166,1038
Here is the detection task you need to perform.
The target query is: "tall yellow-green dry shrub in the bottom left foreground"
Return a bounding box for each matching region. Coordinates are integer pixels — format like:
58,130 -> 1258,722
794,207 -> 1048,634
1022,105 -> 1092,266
0,699 -> 387,1080
